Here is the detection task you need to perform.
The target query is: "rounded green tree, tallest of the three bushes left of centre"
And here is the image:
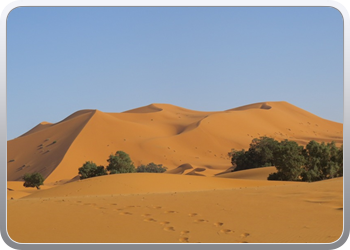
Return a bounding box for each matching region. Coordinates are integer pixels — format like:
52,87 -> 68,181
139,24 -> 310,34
107,151 -> 136,174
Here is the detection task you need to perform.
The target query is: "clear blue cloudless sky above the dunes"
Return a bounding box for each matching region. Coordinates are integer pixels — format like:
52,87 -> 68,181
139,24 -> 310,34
7,7 -> 343,140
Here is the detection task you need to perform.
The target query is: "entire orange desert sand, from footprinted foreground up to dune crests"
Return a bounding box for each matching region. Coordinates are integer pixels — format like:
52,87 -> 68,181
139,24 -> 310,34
7,102 -> 343,243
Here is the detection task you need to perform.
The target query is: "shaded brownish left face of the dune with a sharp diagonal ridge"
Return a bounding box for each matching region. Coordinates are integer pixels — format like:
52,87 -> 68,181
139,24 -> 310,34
7,110 -> 95,181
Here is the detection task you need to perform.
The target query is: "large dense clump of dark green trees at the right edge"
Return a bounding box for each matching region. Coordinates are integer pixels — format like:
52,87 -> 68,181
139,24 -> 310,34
229,136 -> 343,182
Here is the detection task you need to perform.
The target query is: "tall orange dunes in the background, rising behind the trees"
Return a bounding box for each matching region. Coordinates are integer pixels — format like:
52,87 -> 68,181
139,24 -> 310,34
7,102 -> 343,185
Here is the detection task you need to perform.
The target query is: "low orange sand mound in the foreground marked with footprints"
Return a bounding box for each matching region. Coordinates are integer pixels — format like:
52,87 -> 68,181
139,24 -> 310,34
7,172 -> 343,243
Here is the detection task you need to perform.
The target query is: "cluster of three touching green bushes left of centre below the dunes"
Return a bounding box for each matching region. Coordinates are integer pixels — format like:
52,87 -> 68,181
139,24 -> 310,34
79,151 -> 167,179
